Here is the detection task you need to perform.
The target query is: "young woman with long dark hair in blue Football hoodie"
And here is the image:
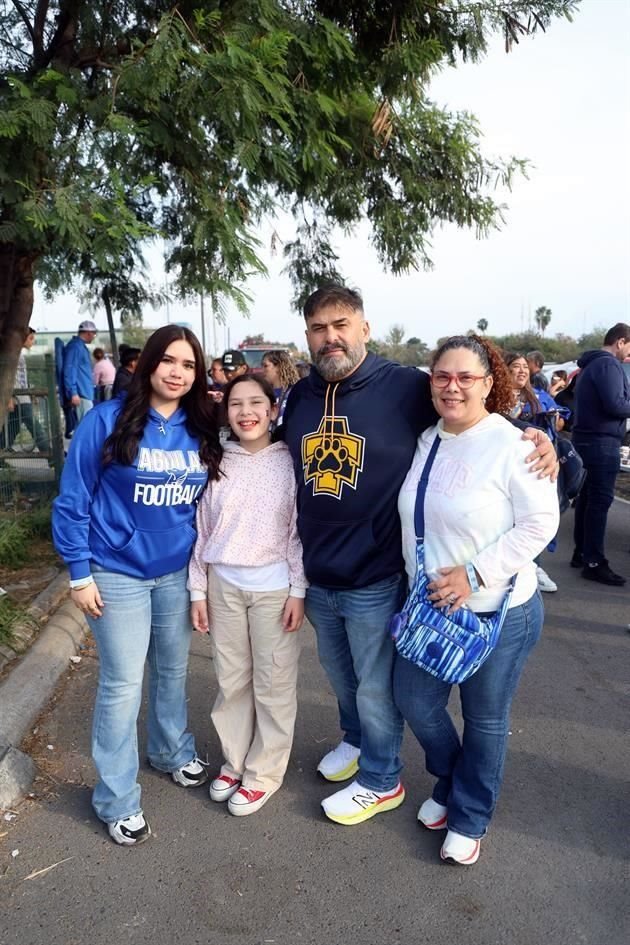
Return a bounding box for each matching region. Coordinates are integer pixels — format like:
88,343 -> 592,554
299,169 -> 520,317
53,325 -> 221,846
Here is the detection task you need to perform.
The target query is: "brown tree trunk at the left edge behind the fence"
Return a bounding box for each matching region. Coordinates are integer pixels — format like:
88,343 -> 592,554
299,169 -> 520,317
0,251 -> 36,425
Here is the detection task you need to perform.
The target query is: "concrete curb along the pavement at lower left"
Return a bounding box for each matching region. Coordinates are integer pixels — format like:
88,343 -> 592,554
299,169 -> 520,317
0,601 -> 87,808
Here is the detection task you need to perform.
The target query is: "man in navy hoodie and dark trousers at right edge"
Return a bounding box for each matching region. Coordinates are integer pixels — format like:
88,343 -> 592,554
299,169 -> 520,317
571,322 -> 630,587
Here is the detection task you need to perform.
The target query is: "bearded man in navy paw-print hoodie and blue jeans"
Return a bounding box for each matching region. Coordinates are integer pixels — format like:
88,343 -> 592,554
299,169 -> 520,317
280,285 -> 555,825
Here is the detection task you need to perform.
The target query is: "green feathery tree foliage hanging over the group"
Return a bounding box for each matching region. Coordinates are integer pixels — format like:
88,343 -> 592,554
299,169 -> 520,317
0,0 -> 576,388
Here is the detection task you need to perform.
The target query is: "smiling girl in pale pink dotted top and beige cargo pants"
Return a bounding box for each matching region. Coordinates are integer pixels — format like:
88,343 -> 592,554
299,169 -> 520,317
188,374 -> 307,817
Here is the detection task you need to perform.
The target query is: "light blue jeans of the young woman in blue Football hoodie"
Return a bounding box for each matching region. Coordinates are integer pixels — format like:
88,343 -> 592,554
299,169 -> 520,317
88,565 -> 195,823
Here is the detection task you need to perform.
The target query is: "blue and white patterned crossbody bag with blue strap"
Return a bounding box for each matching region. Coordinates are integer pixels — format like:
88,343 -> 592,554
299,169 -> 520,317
390,436 -> 515,683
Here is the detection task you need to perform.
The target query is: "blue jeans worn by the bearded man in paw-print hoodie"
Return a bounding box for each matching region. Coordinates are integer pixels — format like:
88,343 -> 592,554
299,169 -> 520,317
305,574 -> 405,791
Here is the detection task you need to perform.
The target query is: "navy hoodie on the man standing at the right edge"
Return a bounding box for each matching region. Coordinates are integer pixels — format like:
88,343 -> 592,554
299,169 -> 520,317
573,349 -> 630,443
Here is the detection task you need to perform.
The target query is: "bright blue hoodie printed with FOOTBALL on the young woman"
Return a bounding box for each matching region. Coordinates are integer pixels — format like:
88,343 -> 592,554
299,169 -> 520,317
53,399 -> 208,580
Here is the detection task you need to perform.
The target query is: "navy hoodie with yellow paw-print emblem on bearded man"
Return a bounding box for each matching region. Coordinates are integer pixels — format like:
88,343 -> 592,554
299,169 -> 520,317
281,353 -> 437,588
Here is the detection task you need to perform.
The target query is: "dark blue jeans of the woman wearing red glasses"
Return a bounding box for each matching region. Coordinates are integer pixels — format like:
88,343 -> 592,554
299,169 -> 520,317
394,592 -> 544,839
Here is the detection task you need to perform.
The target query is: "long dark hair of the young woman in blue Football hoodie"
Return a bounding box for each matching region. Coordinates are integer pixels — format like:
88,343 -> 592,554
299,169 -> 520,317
103,325 -> 223,479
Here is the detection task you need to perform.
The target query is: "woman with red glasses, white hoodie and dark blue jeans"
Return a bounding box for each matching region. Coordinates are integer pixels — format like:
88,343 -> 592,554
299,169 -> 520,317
394,336 -> 559,865
